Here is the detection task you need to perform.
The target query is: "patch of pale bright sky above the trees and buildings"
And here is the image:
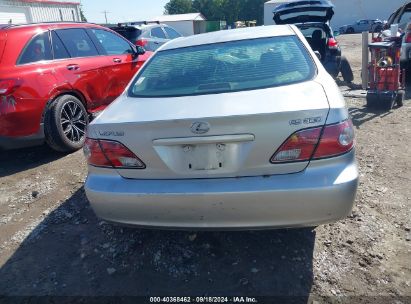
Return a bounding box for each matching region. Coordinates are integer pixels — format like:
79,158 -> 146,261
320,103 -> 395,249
80,0 -> 169,23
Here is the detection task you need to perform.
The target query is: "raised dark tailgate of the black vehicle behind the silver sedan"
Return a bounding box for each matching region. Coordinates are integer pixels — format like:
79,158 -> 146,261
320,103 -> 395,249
273,0 -> 334,24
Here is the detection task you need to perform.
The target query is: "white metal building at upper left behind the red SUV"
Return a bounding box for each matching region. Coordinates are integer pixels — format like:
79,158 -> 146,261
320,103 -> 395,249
0,0 -> 81,22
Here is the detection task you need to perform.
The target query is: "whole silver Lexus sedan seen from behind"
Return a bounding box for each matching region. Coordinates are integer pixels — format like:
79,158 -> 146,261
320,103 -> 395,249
84,25 -> 358,229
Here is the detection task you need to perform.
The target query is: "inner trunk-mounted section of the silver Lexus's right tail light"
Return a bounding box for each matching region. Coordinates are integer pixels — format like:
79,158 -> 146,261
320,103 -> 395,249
271,127 -> 322,164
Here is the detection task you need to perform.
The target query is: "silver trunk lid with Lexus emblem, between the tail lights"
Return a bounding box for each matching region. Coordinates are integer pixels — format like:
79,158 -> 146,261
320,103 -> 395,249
89,81 -> 329,179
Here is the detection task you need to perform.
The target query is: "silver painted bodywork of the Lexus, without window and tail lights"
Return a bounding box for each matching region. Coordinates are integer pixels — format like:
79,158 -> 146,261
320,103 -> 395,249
85,25 -> 358,229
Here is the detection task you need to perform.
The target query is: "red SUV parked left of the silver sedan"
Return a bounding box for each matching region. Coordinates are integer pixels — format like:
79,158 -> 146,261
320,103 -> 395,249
0,23 -> 152,152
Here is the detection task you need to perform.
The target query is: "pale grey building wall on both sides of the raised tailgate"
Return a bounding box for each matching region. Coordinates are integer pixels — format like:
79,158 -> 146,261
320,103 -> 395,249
264,0 -> 405,29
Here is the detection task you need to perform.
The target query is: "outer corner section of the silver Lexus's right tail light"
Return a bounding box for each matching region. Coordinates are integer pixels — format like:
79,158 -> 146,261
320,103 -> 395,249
313,119 -> 354,159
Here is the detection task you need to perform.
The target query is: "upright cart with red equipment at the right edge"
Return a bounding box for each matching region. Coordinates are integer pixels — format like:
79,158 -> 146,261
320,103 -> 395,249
367,37 -> 405,110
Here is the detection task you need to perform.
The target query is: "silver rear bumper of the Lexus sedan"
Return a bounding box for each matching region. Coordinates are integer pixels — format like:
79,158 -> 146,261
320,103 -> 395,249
85,151 -> 358,229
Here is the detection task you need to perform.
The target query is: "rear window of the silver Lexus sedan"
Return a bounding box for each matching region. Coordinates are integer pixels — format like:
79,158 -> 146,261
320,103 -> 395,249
129,36 -> 315,97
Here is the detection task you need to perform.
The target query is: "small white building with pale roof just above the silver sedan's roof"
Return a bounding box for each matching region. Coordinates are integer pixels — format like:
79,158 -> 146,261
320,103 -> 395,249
150,13 -> 207,36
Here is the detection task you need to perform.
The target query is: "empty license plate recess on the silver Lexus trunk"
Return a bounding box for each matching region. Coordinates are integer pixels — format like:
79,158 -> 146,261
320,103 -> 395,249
185,143 -> 227,171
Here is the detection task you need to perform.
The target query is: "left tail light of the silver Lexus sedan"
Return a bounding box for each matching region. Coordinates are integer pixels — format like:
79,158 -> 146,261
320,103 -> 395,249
83,138 -> 146,169
